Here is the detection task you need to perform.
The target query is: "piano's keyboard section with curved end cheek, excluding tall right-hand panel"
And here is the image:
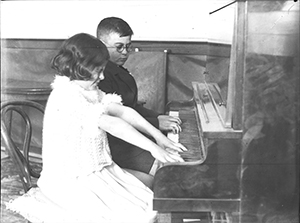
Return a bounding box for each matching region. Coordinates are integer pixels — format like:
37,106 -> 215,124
153,82 -> 242,223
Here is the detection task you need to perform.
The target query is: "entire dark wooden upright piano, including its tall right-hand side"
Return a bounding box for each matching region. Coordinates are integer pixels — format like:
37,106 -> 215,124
153,1 -> 300,223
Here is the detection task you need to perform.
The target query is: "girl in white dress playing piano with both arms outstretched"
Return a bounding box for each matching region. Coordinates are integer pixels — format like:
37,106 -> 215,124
10,33 -> 185,223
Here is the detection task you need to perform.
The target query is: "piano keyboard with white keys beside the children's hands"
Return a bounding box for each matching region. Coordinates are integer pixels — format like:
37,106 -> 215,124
168,110 -> 206,163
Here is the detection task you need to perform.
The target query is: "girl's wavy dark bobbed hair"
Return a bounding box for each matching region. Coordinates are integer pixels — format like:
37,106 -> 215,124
51,33 -> 109,80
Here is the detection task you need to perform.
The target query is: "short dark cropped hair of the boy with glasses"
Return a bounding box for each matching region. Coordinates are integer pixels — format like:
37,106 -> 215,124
97,17 -> 133,39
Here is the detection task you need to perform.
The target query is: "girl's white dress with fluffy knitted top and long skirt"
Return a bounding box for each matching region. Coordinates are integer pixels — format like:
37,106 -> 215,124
8,76 -> 156,223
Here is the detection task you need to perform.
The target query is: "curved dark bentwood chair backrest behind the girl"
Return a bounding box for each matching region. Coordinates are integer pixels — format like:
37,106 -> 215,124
1,101 -> 45,192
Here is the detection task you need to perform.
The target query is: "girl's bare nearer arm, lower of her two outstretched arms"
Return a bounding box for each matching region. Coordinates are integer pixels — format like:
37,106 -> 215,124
99,115 -> 183,163
